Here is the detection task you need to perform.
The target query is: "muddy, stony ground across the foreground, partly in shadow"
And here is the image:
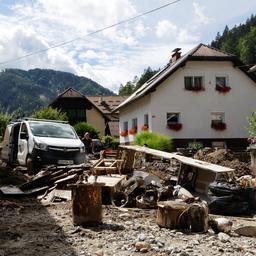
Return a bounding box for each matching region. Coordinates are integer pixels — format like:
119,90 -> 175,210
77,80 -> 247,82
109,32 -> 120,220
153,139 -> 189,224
0,198 -> 256,256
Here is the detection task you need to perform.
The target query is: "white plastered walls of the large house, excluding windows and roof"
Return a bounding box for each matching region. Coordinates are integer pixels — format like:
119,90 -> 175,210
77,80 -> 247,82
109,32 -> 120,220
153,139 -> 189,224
120,61 -> 256,142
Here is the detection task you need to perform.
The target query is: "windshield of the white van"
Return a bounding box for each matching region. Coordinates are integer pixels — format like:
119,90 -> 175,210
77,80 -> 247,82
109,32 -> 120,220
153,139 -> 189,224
29,122 -> 77,139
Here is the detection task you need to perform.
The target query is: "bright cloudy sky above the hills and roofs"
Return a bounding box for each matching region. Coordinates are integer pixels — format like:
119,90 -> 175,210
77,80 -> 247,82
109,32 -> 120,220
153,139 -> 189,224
0,0 -> 256,92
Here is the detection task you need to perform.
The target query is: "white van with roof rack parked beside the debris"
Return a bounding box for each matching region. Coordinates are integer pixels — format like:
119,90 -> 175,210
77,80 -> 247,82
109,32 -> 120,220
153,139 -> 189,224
1,118 -> 85,174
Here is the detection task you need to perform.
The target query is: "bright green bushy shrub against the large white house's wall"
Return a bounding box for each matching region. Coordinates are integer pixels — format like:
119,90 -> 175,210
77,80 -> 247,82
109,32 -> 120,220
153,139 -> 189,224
133,131 -> 172,152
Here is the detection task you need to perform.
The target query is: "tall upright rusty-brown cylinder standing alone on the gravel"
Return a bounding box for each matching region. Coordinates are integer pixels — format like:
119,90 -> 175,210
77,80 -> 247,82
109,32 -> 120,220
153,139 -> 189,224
69,183 -> 103,226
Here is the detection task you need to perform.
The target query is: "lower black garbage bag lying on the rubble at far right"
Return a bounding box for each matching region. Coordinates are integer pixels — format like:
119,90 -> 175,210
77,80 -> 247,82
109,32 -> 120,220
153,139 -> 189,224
208,195 -> 250,216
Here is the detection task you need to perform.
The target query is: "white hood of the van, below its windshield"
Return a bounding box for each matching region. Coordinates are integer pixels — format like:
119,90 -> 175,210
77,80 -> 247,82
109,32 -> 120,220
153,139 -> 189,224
35,137 -> 84,148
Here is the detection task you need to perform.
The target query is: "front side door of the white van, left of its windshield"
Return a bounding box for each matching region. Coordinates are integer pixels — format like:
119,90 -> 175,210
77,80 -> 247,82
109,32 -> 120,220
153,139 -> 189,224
18,123 -> 28,165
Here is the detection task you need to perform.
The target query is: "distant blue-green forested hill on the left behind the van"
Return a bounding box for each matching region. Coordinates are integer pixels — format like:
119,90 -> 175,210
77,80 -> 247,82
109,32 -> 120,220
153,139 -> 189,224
0,69 -> 114,114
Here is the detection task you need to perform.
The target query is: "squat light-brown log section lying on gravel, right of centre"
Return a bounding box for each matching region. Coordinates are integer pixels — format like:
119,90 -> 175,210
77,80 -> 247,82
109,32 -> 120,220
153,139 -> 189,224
156,201 -> 189,229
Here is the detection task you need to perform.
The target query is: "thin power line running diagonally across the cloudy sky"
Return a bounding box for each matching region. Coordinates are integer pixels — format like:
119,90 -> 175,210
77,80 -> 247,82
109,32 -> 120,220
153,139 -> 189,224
0,0 -> 182,65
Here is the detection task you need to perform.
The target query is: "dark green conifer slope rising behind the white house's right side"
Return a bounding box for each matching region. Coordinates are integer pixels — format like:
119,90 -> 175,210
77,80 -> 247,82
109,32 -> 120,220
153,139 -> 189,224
211,15 -> 256,64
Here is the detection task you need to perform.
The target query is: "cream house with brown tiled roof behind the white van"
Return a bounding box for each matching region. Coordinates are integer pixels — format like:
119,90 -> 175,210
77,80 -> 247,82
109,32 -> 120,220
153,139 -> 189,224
50,88 -> 127,137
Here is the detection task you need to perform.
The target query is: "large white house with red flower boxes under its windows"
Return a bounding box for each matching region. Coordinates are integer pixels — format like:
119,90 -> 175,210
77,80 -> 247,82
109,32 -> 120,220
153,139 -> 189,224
115,44 -> 256,148
